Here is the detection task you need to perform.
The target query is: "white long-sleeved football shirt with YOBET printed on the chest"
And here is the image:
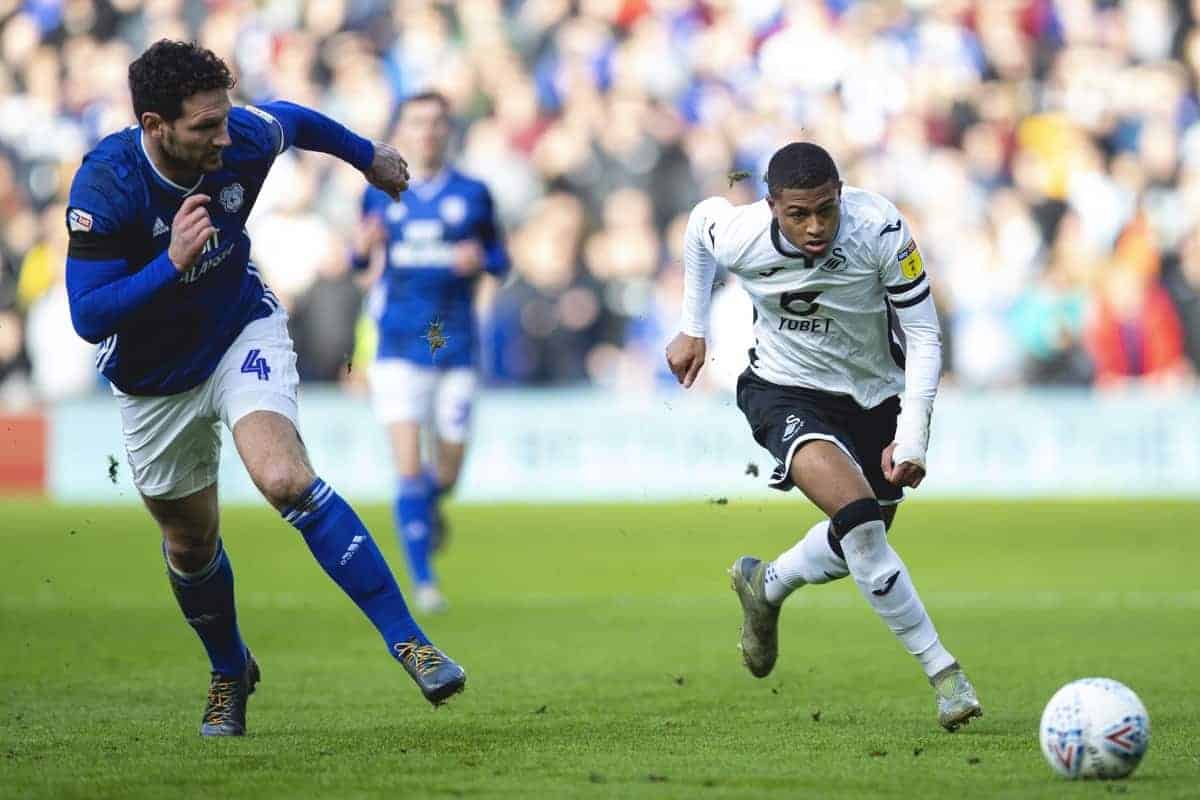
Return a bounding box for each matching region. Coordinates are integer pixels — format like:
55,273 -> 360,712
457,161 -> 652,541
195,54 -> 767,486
683,186 -> 941,465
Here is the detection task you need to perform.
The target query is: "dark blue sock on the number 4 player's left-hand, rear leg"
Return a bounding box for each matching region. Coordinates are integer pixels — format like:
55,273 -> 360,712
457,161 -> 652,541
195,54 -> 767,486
162,539 -> 246,678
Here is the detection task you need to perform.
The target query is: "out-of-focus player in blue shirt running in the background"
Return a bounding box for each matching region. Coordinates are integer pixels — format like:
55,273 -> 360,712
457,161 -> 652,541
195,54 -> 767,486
354,91 -> 509,612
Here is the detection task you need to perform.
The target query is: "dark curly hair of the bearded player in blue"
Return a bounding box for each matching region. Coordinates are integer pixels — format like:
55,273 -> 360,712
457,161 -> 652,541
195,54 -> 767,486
130,38 -> 236,125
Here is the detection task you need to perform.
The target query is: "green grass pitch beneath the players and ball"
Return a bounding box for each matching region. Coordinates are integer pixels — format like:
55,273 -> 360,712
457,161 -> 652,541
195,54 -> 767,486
0,497 -> 1200,800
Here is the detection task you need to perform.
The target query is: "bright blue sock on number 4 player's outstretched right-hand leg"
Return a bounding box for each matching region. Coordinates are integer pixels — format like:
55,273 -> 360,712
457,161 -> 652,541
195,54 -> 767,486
282,477 -> 430,656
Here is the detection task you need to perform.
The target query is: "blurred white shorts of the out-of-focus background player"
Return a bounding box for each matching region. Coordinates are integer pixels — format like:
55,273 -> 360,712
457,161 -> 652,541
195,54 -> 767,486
370,359 -> 479,444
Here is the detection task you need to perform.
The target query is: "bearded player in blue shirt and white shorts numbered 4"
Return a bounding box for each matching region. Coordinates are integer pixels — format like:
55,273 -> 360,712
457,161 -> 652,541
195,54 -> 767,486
64,40 -> 466,736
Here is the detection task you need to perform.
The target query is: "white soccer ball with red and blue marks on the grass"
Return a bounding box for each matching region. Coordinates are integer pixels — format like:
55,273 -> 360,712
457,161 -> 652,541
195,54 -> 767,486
1039,678 -> 1150,778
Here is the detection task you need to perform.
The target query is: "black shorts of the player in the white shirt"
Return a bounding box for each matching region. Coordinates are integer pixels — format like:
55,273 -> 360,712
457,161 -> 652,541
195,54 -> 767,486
738,369 -> 904,505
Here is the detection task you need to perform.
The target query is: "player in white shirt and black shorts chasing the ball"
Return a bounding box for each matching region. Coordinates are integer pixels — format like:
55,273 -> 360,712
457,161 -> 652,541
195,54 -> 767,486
667,142 -> 982,730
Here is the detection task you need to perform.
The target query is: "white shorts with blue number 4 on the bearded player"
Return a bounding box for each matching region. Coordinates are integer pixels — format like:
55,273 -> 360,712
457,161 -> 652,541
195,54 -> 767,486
113,308 -> 300,500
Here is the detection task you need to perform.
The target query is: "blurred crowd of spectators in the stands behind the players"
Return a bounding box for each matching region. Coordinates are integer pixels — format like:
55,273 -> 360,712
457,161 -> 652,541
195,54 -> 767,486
0,0 -> 1200,404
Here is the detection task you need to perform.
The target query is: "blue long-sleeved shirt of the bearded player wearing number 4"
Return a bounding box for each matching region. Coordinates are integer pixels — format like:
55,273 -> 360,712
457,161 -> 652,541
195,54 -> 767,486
66,102 -> 374,396
